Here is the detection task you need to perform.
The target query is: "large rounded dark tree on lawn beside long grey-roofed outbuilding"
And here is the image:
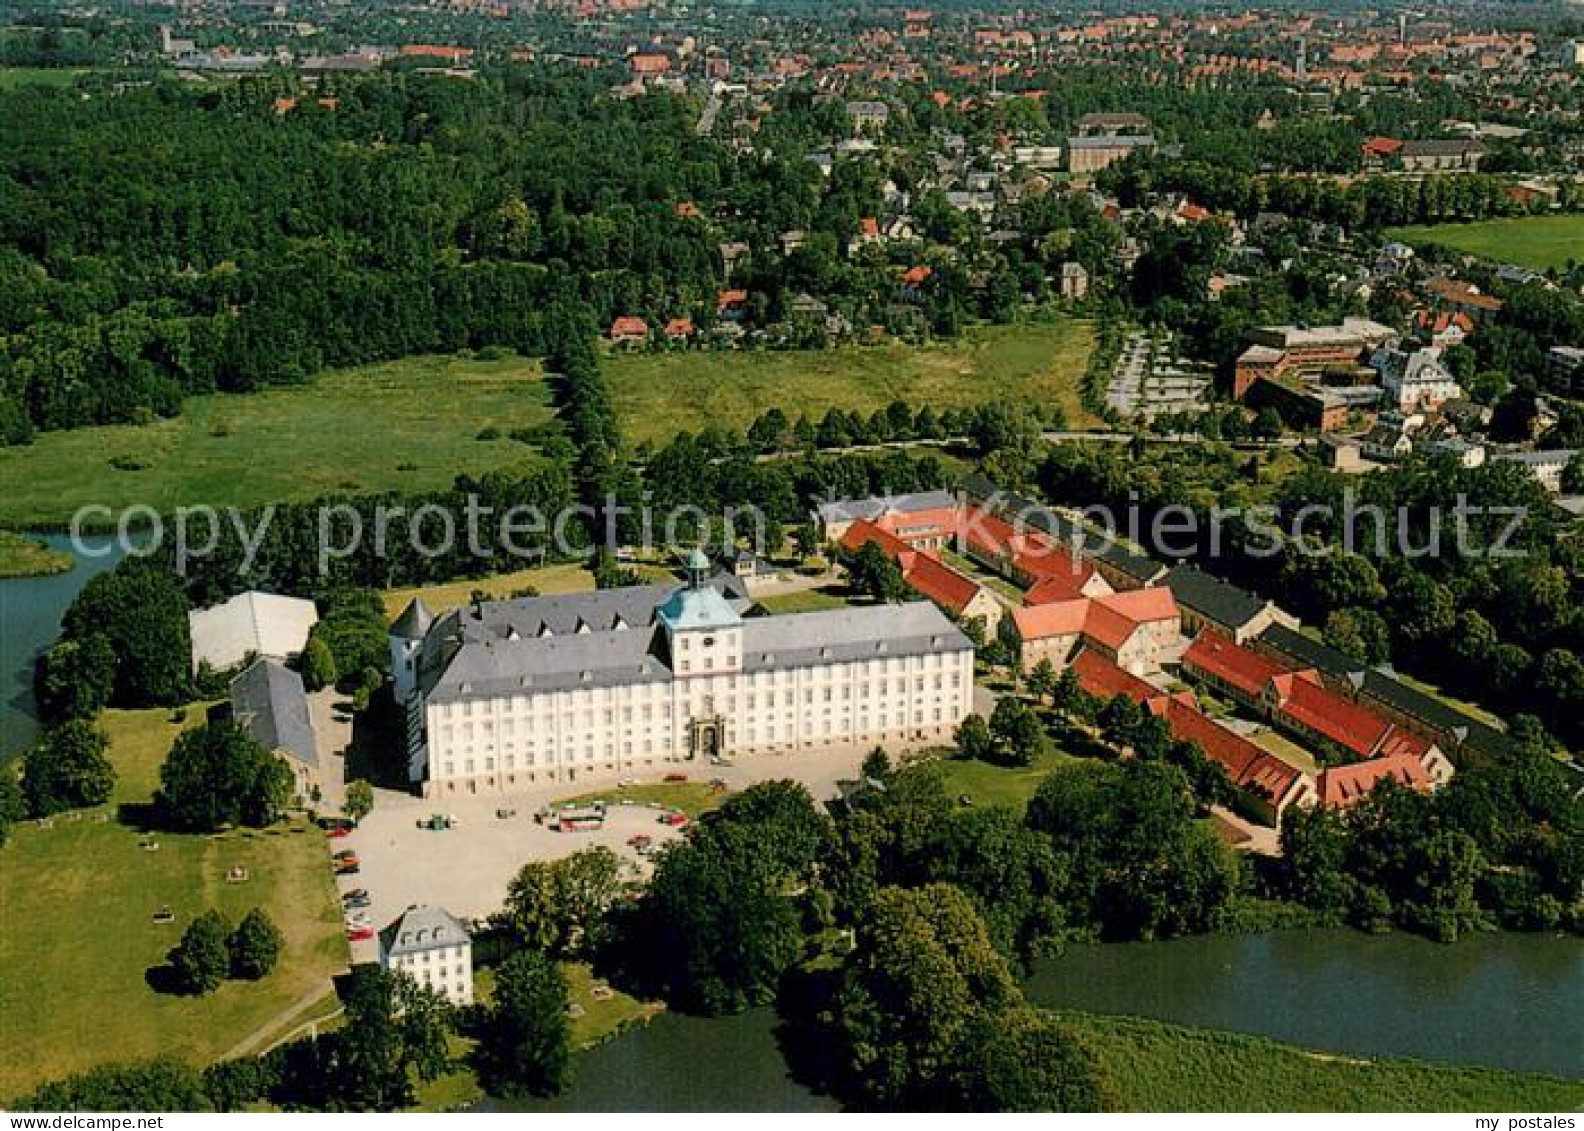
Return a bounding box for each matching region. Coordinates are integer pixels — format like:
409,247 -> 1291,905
155,719 -> 293,832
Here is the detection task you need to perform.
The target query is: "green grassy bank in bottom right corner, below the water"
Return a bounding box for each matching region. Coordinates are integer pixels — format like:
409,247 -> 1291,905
1064,1014 -> 1584,1112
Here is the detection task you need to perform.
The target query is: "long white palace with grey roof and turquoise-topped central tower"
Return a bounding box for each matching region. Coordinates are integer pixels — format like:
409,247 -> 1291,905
391,551 -> 974,797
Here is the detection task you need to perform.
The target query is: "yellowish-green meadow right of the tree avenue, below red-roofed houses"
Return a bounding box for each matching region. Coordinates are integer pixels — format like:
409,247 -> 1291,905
605,322 -> 1095,442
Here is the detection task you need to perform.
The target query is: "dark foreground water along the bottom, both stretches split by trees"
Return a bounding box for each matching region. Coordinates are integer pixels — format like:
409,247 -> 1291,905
480,930 -> 1584,1112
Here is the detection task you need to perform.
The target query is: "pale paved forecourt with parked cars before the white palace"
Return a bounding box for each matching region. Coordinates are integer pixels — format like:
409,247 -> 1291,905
325,749 -> 868,962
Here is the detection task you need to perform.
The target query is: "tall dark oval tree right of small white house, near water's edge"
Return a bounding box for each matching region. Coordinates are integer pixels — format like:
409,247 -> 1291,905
477,950 -> 572,1098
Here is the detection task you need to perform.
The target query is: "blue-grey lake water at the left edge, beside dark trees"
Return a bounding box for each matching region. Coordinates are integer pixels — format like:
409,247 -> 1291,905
0,534 -> 122,762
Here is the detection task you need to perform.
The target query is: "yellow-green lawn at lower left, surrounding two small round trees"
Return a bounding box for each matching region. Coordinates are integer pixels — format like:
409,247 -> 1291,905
0,708 -> 347,1104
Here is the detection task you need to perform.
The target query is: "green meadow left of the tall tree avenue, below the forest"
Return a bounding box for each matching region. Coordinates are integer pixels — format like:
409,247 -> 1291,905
0,356 -> 551,527
